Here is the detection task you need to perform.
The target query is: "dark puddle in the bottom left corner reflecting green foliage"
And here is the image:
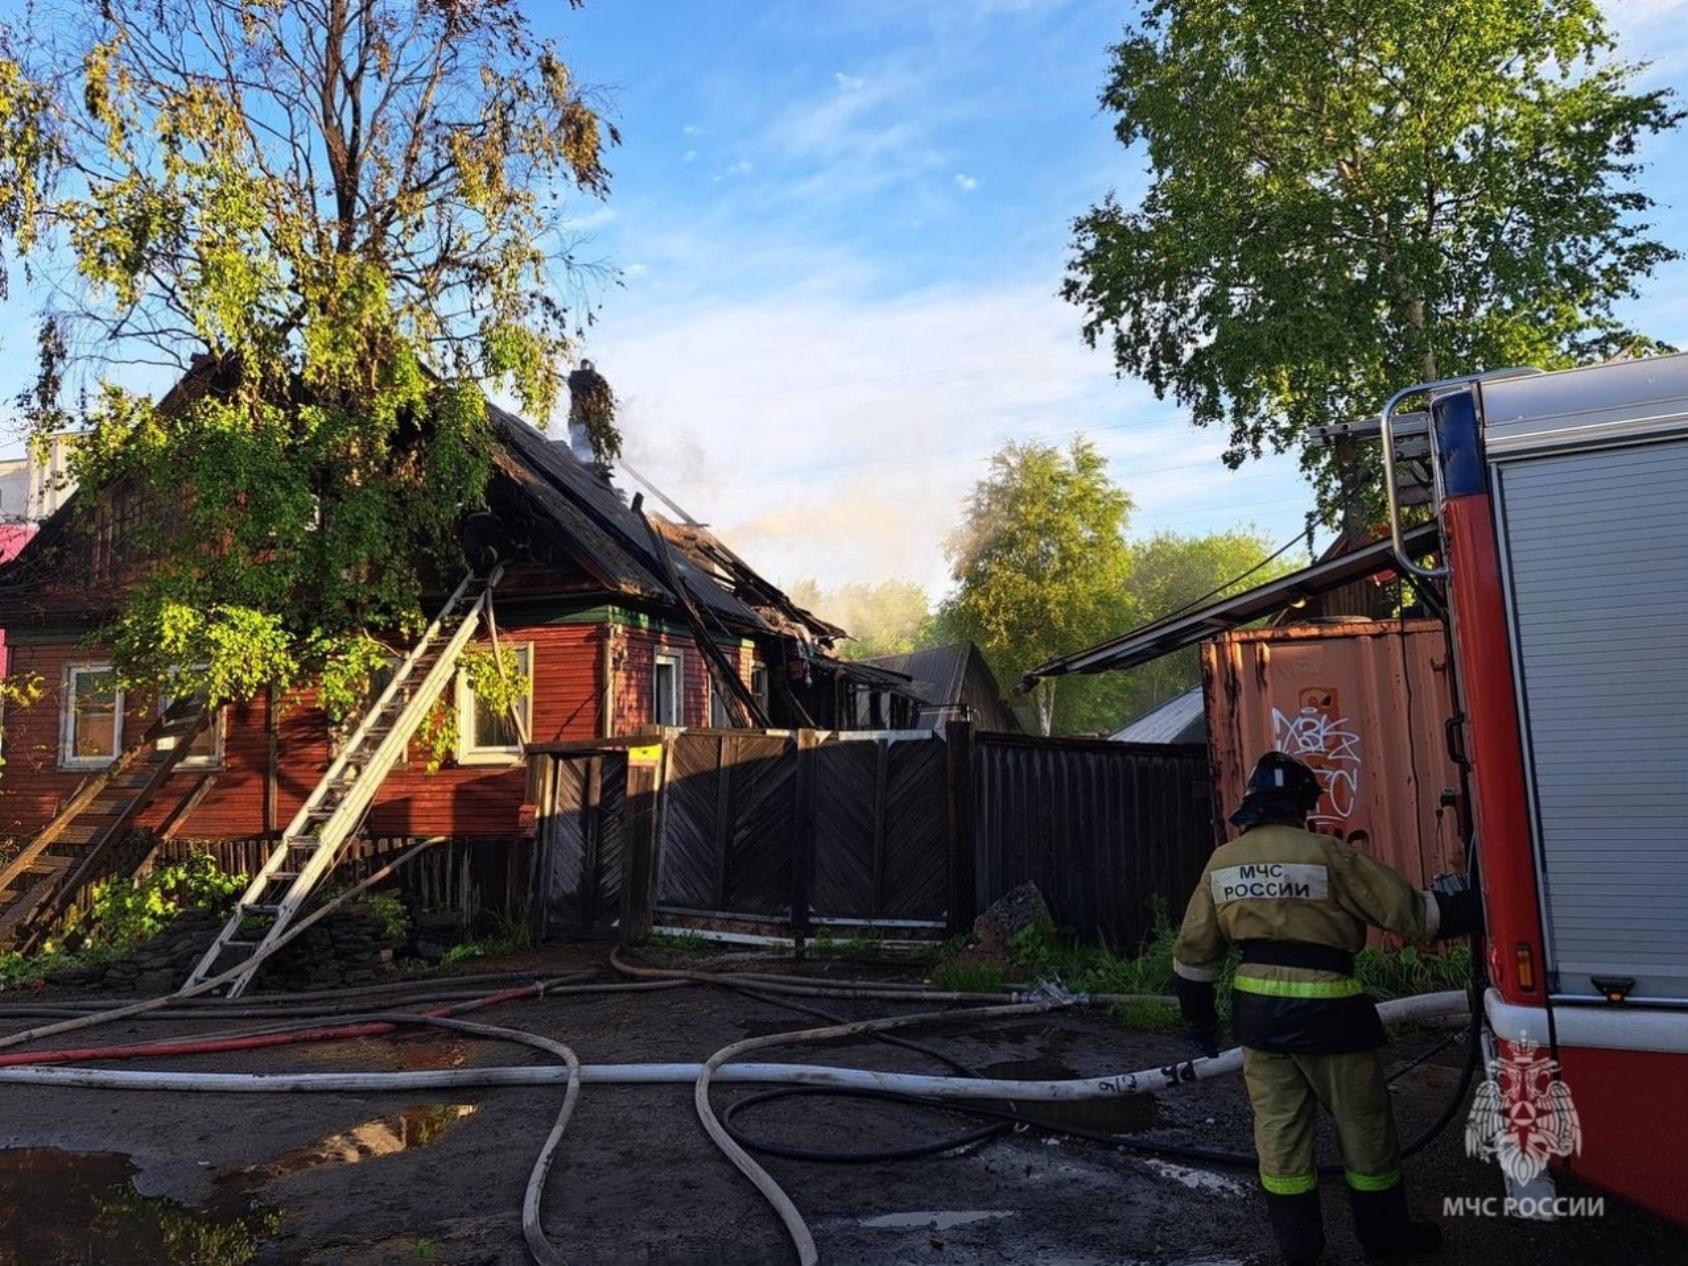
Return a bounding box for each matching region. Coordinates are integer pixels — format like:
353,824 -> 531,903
0,1148 -> 282,1266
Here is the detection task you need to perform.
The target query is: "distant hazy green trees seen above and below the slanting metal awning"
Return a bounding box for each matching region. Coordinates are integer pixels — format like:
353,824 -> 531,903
1119,530 -> 1298,724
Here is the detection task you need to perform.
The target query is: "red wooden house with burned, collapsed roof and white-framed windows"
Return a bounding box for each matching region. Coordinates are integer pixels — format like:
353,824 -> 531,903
0,398 -> 906,854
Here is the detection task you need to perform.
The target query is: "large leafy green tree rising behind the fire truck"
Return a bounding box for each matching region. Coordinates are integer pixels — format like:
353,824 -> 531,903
1063,0 -> 1681,516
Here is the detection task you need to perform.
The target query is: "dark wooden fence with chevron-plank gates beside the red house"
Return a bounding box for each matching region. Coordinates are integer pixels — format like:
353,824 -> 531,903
528,722 -> 1212,945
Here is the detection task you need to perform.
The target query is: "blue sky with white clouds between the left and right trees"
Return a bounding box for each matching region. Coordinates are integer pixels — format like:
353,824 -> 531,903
0,0 -> 1688,592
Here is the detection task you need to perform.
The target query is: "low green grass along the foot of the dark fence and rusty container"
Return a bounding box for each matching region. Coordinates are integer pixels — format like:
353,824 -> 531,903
927,910 -> 1472,1031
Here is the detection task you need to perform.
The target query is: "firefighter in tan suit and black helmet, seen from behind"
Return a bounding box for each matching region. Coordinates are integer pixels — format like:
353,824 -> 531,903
1173,751 -> 1482,1266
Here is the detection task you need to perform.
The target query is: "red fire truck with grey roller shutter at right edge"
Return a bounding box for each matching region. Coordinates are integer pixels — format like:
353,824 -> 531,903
1379,354 -> 1688,1222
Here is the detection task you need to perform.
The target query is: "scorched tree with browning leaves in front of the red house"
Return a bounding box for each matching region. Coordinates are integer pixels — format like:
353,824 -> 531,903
0,0 -> 614,715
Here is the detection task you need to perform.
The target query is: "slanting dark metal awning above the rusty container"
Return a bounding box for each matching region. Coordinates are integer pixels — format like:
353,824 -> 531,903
1020,523 -> 1440,690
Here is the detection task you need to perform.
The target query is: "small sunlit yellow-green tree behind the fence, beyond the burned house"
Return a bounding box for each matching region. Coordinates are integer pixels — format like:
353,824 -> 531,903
942,437 -> 1131,734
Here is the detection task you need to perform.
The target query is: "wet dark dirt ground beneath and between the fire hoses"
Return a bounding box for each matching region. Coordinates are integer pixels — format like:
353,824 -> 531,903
0,950 -> 1688,1266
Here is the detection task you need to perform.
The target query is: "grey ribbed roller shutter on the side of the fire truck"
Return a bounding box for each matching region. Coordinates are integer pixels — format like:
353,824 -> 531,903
1494,432 -> 1688,1001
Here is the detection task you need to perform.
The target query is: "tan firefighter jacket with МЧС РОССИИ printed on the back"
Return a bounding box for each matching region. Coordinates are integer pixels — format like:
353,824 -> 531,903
1173,824 -> 1440,1052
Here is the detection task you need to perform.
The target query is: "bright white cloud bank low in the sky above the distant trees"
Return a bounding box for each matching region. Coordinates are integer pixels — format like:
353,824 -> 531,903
591,284 -> 1308,592
